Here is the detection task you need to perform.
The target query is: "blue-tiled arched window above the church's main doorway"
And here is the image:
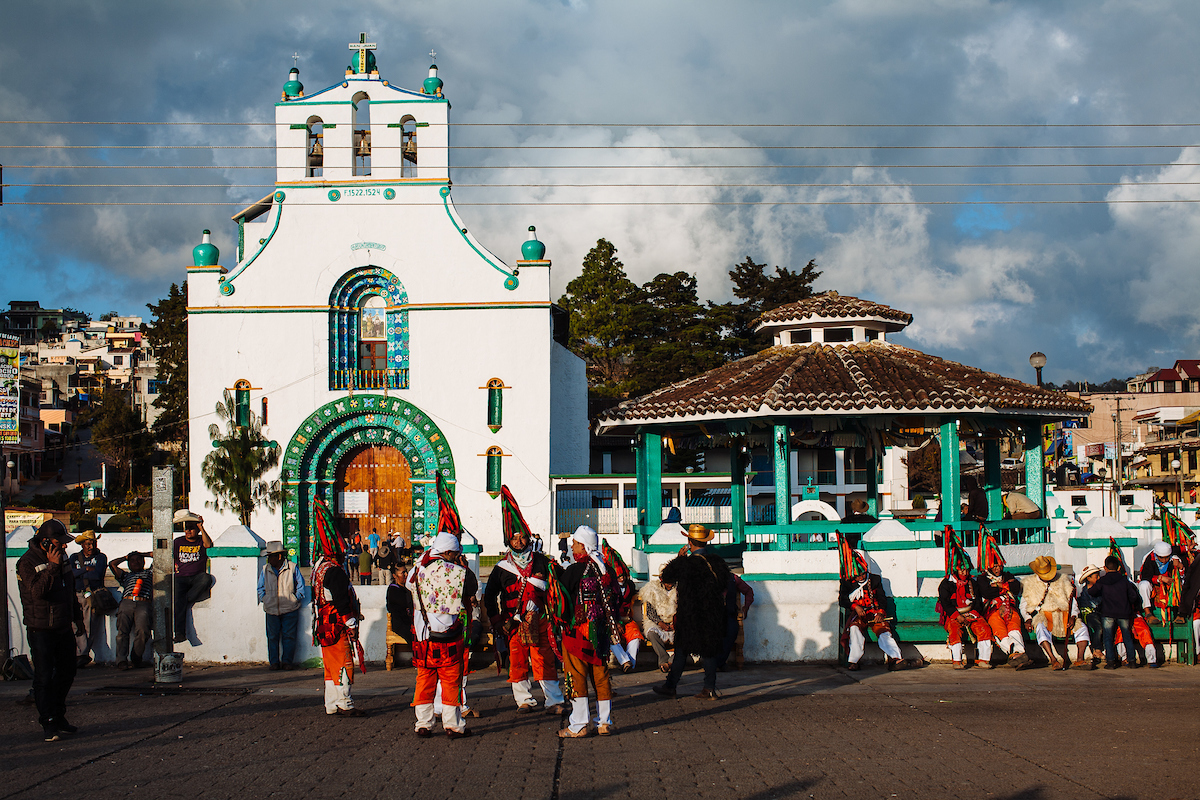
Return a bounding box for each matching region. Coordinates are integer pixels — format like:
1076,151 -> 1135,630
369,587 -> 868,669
329,266 -> 408,390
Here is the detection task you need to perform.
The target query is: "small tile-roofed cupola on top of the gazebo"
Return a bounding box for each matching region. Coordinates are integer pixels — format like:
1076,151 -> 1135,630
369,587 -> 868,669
755,291 -> 912,347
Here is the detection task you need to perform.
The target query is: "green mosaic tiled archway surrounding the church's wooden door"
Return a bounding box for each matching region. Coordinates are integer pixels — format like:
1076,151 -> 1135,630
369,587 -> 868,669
282,395 -> 455,564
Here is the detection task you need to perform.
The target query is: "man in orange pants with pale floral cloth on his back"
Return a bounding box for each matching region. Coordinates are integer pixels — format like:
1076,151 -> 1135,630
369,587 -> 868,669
407,533 -> 479,739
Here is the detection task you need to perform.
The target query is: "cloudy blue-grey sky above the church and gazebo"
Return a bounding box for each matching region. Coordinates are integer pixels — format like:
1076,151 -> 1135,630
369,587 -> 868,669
0,0 -> 1200,381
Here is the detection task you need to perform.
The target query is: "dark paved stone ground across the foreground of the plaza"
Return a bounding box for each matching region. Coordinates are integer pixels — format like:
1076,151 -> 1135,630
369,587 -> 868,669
0,666 -> 1200,800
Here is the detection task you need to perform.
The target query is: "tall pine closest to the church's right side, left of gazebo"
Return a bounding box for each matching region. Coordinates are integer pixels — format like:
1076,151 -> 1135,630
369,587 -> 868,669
558,239 -> 643,397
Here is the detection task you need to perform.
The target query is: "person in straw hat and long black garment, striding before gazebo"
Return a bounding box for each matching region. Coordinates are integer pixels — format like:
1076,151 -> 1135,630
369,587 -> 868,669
654,525 -> 730,700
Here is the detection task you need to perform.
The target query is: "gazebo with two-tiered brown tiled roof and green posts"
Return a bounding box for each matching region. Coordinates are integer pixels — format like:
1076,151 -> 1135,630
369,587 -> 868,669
596,291 -> 1091,561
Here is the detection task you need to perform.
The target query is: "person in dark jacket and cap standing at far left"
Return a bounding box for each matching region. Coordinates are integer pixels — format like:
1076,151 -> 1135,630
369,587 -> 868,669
17,519 -> 83,741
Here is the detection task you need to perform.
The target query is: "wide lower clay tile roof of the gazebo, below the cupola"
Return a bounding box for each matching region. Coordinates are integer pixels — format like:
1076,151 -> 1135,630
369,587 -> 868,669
598,342 -> 1092,431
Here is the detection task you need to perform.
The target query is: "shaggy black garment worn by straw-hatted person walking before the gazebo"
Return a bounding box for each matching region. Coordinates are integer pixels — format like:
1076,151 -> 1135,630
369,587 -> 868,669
661,554 -> 730,657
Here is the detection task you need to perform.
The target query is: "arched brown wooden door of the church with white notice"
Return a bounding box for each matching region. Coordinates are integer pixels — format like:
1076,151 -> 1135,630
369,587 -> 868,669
335,445 -> 413,551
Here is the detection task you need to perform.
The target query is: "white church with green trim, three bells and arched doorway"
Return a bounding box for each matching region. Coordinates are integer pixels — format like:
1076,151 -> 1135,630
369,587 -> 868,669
187,37 -> 588,564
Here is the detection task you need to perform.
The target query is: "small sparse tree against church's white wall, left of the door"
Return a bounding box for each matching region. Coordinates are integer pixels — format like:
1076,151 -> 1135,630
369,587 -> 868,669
200,390 -> 283,528
